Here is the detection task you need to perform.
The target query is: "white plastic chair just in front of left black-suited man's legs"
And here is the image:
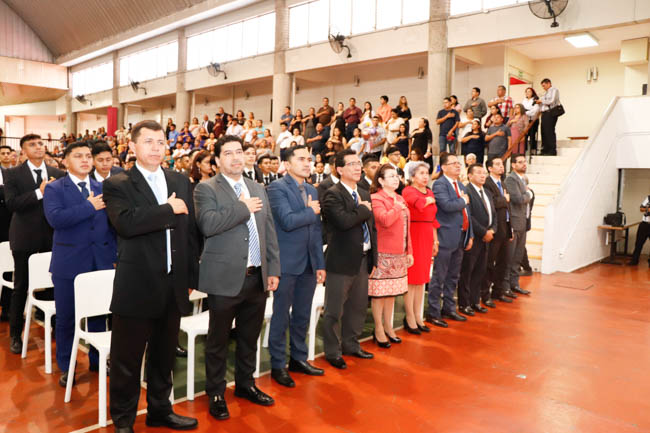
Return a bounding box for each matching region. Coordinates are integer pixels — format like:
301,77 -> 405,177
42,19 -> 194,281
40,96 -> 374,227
21,252 -> 56,374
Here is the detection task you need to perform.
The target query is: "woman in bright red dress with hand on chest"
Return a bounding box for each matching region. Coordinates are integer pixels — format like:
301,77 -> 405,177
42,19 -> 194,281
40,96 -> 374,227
402,162 -> 440,334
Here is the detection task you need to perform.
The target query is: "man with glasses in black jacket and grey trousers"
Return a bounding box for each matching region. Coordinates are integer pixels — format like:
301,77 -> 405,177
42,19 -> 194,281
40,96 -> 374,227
322,149 -> 377,369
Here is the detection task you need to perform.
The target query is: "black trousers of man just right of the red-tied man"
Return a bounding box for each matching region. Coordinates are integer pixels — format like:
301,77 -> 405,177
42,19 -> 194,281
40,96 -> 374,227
458,237 -> 490,308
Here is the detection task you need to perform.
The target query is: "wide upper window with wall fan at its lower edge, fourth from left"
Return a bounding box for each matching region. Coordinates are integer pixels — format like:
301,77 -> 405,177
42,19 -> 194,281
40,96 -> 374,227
289,0 -> 430,48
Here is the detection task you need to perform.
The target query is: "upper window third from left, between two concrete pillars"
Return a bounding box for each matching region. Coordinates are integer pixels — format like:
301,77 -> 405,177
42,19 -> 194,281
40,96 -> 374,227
187,12 -> 275,70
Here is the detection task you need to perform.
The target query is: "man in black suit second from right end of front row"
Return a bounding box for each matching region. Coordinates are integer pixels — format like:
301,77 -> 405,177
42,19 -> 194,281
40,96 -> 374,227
481,158 -> 517,307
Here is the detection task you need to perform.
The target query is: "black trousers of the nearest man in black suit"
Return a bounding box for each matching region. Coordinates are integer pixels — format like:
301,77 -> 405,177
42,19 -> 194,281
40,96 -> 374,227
110,276 -> 181,427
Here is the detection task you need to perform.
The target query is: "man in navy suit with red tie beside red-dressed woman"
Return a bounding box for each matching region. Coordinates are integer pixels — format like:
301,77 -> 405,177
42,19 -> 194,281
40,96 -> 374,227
427,152 -> 474,328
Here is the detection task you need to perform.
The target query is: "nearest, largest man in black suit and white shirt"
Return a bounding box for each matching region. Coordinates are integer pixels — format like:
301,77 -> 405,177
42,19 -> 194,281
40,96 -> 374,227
103,120 -> 198,432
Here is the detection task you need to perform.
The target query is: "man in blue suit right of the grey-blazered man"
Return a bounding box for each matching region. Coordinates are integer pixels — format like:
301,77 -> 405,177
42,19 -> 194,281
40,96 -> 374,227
267,146 -> 325,388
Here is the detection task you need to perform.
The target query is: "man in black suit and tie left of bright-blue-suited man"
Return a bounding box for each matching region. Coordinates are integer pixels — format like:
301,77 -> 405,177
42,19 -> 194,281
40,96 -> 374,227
4,134 -> 65,354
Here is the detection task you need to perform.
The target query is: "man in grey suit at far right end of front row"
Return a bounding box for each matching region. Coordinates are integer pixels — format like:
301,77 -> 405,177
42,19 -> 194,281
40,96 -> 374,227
504,154 -> 533,295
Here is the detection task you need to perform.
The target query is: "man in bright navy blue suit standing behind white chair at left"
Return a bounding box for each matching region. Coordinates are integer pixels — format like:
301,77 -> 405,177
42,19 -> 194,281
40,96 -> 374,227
43,142 -> 117,387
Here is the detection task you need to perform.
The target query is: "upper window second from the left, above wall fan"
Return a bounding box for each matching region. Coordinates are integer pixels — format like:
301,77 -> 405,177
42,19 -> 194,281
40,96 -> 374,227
120,41 -> 177,86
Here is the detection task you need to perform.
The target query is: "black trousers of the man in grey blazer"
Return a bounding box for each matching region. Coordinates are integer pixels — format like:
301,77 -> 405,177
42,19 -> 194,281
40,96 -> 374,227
205,269 -> 268,397
